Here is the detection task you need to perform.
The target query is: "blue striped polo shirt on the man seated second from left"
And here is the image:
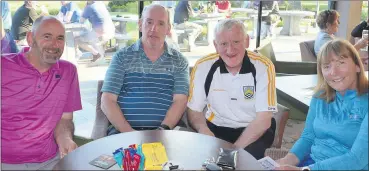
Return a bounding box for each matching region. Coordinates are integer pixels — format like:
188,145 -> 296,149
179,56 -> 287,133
101,40 -> 189,128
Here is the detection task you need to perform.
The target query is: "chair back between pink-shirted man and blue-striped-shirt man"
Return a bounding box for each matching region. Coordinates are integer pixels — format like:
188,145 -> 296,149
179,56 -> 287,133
91,80 -> 109,140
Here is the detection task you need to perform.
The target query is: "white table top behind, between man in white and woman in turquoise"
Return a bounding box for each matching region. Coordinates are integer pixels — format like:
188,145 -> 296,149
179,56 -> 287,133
276,72 -> 368,111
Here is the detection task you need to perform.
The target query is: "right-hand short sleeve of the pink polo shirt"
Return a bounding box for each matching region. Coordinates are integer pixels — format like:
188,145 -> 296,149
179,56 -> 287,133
63,65 -> 82,112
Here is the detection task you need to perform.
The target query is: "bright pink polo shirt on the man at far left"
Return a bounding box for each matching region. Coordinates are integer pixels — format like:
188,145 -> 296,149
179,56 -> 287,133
1,49 -> 82,164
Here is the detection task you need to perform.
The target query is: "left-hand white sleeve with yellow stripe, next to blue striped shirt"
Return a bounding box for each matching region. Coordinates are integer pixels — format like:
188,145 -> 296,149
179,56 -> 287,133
187,64 -> 207,112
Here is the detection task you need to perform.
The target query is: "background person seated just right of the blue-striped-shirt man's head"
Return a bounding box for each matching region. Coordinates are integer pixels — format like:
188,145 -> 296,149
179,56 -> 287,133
174,0 -> 203,47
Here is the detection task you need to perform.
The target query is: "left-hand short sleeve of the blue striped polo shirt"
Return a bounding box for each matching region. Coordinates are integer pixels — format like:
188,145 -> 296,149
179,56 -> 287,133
101,51 -> 125,95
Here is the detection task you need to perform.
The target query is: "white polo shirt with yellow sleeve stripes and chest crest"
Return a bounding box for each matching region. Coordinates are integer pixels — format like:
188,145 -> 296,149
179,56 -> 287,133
187,51 -> 277,128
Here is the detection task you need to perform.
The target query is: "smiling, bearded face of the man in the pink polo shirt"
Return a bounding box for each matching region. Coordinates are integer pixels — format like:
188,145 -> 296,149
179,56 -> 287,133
27,19 -> 65,65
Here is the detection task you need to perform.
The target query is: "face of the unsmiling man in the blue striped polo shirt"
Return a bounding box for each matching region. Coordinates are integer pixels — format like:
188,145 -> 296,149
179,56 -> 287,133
139,6 -> 170,47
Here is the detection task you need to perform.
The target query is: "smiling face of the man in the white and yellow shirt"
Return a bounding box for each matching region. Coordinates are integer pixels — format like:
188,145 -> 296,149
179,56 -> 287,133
214,26 -> 248,72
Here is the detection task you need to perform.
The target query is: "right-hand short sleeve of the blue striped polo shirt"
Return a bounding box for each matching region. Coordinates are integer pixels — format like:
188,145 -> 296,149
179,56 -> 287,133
173,55 -> 189,95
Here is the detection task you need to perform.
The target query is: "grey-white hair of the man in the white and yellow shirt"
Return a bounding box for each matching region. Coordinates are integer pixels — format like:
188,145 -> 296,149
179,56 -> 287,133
214,19 -> 247,39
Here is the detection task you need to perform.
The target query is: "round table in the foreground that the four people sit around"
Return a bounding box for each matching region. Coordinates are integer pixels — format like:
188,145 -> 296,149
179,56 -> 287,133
54,130 -> 262,170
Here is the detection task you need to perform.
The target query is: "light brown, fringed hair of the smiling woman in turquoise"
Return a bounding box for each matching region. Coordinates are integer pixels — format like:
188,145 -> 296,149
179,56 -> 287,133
314,39 -> 368,102
